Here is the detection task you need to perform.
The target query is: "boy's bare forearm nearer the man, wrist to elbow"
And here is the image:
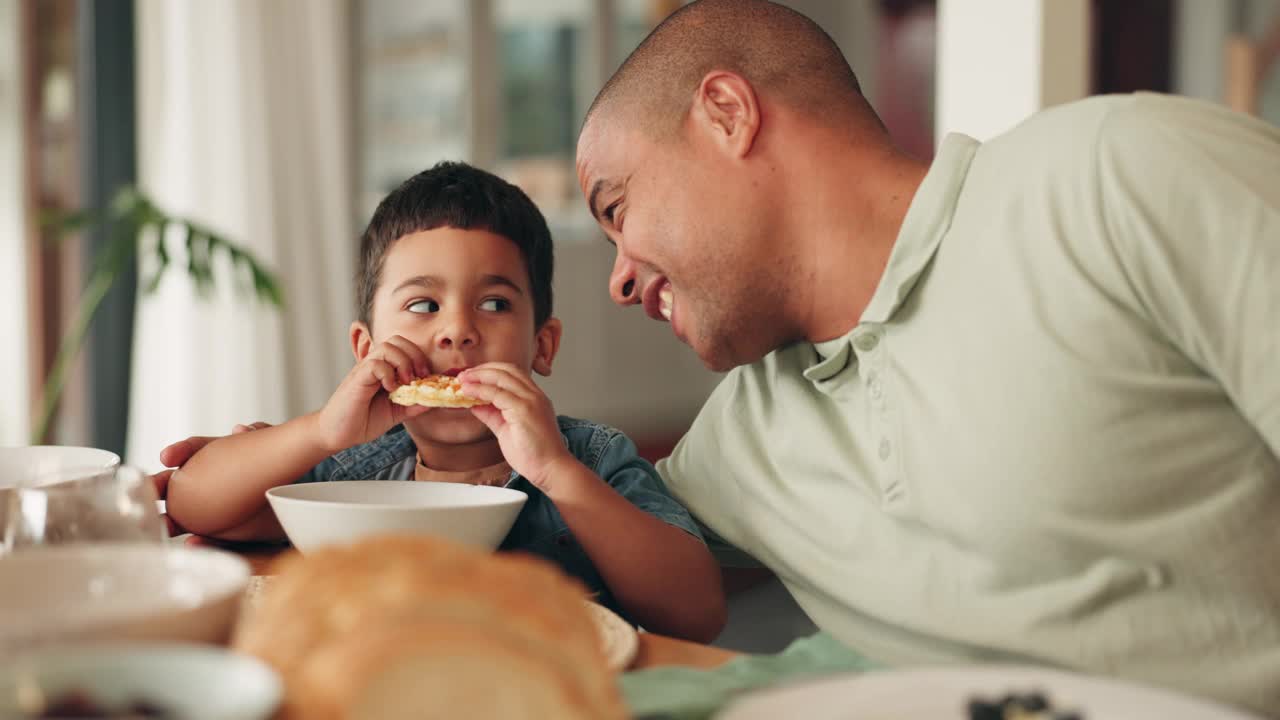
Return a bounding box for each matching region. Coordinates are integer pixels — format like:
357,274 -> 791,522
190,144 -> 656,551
543,456 -> 727,642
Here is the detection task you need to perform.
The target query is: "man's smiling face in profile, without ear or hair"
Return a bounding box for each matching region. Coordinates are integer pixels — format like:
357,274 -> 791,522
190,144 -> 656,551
577,119 -> 791,370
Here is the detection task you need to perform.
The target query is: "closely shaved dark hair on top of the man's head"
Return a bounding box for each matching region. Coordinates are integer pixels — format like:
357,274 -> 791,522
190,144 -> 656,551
584,0 -> 878,137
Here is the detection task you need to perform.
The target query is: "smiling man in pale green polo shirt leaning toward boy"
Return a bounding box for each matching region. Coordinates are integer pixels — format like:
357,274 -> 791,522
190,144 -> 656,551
577,0 -> 1280,715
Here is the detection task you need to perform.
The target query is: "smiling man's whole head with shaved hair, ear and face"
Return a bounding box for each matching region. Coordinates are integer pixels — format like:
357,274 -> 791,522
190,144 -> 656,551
576,0 -> 900,370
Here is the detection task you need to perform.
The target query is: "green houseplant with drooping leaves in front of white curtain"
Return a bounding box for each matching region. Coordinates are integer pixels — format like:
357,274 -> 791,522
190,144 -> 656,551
32,186 -> 284,445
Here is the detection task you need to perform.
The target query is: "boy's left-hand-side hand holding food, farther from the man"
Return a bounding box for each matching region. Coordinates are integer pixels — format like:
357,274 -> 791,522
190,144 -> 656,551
316,336 -> 431,454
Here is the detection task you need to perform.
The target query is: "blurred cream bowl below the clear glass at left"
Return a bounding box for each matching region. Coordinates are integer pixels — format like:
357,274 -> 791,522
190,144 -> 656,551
0,543 -> 250,657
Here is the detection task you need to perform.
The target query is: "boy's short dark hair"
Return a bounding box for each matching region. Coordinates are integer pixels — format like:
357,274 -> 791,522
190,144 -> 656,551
356,163 -> 554,329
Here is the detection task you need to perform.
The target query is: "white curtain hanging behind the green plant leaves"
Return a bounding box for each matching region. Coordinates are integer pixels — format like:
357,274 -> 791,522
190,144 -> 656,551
127,0 -> 357,469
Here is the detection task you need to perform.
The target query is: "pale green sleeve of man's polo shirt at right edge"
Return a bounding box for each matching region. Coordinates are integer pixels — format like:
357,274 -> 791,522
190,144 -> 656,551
1097,95 -> 1280,456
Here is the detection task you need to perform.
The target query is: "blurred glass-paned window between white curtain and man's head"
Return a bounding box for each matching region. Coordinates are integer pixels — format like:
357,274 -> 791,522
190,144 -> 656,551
360,0 -> 673,241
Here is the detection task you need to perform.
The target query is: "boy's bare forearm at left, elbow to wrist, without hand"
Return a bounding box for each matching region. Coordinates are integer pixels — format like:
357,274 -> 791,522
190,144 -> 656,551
168,415 -> 330,536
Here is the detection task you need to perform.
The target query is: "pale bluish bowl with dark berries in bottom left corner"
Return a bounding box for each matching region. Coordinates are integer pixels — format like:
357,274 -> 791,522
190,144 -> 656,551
0,644 -> 283,720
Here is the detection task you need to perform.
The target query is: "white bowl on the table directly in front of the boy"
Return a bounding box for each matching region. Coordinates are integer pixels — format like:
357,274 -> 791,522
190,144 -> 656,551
266,480 -> 529,552
